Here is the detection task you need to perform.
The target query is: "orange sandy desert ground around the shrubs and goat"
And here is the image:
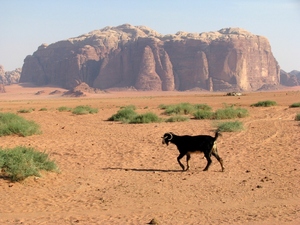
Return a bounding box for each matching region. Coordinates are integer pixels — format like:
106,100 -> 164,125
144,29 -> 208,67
0,85 -> 300,225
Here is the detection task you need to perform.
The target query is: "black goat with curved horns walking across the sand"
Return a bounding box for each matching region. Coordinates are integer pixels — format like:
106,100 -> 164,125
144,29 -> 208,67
162,131 -> 225,171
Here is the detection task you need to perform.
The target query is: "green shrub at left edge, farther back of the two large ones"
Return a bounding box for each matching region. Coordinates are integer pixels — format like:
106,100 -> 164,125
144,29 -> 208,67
0,113 -> 41,137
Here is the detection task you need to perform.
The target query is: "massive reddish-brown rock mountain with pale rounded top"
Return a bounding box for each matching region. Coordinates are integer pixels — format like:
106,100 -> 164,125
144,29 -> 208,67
20,24 -> 280,91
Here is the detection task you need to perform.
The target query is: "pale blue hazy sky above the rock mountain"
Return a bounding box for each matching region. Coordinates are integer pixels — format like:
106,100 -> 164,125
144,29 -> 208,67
0,0 -> 300,72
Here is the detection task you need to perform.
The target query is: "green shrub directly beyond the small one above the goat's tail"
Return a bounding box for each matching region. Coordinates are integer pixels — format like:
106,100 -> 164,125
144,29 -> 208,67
212,106 -> 249,120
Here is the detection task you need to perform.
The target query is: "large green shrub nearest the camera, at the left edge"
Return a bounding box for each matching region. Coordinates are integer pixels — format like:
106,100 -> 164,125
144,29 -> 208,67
0,146 -> 58,181
